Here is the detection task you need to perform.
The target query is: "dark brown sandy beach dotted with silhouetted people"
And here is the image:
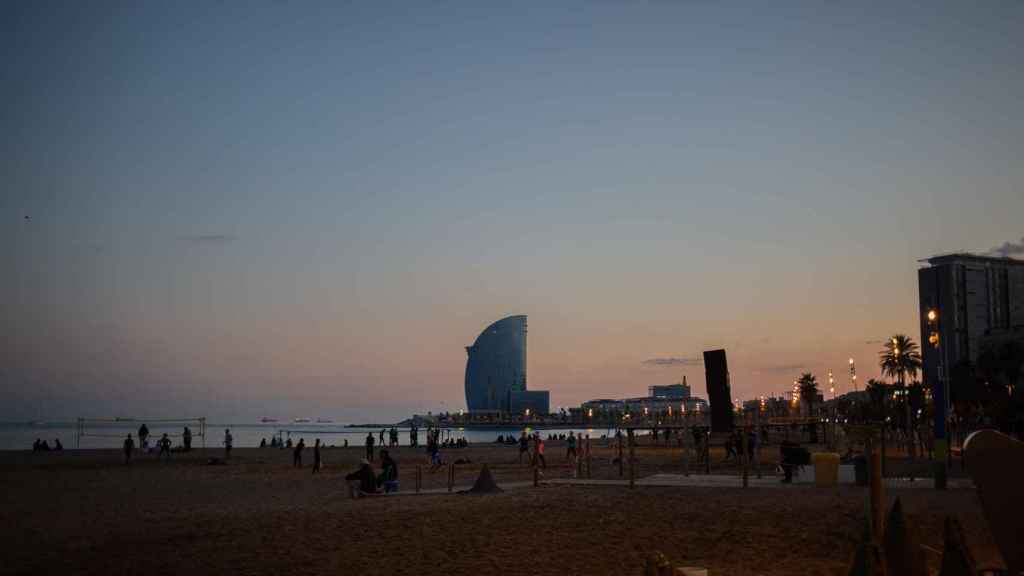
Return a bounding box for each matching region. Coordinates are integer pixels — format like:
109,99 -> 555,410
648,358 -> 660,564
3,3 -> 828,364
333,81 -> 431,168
0,439 -> 994,575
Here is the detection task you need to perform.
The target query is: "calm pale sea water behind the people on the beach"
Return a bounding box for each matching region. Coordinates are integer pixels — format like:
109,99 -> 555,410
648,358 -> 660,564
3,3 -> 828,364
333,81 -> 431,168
0,421 -> 614,450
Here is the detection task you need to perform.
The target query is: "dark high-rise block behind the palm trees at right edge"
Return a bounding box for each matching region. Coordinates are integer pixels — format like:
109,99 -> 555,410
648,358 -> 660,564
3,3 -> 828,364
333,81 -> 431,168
918,254 -> 1024,382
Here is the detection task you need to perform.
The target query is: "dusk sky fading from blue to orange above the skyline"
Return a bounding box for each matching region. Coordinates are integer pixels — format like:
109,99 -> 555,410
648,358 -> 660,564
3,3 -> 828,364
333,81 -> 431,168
0,0 -> 1024,421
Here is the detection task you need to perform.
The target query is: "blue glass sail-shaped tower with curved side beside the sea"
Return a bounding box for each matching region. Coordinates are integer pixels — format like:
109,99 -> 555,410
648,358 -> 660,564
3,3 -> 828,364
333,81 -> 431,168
466,316 -> 549,414
